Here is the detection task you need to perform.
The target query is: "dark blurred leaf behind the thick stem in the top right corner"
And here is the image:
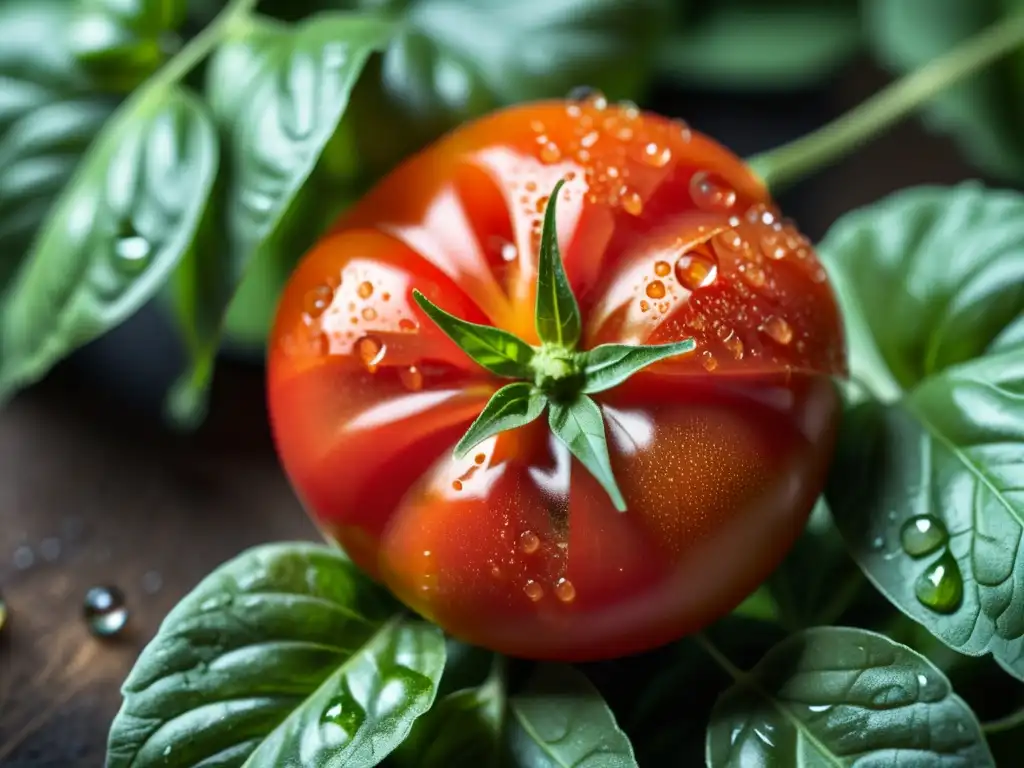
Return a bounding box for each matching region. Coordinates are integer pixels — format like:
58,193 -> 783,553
863,0 -> 1024,180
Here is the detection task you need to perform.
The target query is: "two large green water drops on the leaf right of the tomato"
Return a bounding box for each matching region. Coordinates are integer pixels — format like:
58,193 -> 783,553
899,515 -> 964,613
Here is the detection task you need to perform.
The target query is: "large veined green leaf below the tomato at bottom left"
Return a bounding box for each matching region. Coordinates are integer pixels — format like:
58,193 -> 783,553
106,544 -> 444,768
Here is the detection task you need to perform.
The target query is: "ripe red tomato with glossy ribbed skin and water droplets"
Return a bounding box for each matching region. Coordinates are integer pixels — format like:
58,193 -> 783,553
269,97 -> 846,660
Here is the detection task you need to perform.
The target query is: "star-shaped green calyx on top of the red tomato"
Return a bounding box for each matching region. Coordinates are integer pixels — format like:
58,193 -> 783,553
413,180 -> 696,512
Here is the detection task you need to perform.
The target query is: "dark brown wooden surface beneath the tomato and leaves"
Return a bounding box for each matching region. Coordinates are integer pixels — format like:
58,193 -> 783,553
0,61 -> 977,768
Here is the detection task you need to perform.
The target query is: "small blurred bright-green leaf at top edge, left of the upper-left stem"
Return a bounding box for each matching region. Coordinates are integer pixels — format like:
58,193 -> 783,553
71,0 -> 187,93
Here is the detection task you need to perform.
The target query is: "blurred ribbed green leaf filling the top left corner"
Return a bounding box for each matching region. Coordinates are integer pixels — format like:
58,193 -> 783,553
0,0 -> 116,294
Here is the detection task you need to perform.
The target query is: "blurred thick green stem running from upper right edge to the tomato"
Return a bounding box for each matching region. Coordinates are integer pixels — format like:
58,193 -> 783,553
750,13 -> 1024,193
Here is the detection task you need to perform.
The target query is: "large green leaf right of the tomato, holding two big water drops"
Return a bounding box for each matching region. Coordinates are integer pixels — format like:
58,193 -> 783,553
820,184 -> 1024,679
